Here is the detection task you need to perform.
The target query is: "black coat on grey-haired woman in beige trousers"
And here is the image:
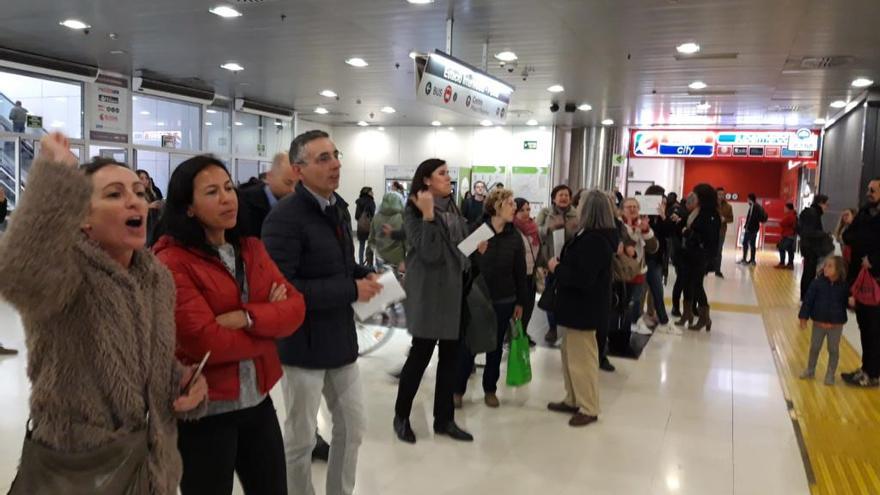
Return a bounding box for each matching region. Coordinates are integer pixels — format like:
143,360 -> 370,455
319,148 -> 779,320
554,229 -> 620,330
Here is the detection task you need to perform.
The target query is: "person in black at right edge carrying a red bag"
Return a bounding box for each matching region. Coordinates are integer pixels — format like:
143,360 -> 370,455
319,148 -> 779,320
841,177 -> 880,387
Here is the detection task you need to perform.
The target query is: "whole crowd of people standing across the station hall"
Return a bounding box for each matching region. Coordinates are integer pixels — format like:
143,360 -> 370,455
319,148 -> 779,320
0,131 -> 880,495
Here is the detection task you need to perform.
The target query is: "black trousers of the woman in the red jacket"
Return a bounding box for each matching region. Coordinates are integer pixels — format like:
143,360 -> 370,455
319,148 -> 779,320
177,397 -> 287,495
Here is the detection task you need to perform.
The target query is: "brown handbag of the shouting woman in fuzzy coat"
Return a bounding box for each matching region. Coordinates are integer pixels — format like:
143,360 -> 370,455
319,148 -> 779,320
9,422 -> 150,495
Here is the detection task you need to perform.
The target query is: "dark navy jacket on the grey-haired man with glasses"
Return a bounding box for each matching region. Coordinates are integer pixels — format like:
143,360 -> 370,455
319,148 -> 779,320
263,183 -> 369,369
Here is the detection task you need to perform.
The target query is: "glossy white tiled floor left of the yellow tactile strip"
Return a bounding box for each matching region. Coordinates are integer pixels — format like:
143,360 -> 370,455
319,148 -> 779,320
0,252 -> 809,495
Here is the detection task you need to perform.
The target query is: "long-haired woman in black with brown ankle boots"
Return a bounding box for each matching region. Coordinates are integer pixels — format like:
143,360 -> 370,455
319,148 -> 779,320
679,184 -> 721,332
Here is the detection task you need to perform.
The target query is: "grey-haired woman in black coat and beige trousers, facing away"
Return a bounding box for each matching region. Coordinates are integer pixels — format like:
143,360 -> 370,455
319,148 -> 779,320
547,189 -> 622,426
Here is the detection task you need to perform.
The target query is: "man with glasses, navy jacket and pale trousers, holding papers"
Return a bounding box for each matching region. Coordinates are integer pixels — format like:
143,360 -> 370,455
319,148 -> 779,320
263,131 -> 382,494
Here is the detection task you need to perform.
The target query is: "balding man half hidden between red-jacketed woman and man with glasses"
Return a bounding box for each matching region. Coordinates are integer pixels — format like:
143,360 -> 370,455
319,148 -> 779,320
238,153 -> 299,237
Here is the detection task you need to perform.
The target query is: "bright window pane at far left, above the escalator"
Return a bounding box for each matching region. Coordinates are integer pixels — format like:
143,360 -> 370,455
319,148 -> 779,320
0,70 -> 83,139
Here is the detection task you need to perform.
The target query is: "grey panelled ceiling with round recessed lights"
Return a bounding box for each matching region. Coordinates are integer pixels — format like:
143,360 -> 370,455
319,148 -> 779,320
0,0 -> 880,127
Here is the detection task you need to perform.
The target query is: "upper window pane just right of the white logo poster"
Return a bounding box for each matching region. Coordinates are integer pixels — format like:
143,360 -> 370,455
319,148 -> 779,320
132,95 -> 201,150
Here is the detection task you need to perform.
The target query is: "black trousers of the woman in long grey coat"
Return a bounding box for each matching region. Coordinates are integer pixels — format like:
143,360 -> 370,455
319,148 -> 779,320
394,337 -> 458,424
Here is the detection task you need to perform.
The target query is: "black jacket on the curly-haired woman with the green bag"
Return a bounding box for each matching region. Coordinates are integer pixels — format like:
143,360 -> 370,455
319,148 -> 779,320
477,222 -> 528,307
